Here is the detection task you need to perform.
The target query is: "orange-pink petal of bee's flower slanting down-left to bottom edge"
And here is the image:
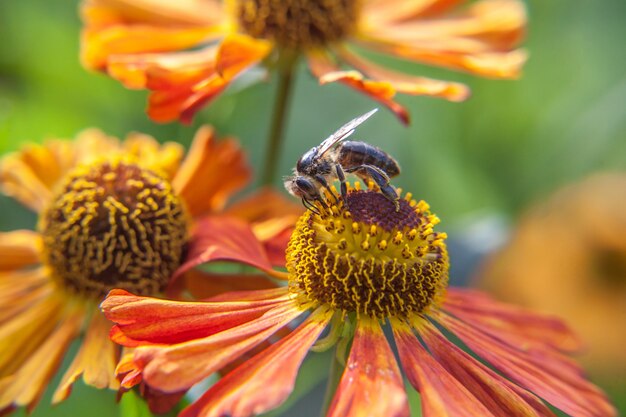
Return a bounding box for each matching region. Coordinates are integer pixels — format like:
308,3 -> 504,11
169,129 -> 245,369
180,310 -> 331,417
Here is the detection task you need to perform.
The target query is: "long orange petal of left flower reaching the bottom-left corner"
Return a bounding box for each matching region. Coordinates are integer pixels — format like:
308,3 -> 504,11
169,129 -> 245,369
0,314 -> 82,412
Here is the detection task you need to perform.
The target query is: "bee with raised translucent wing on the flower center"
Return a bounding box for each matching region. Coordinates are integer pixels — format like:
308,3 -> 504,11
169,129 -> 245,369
285,109 -> 400,212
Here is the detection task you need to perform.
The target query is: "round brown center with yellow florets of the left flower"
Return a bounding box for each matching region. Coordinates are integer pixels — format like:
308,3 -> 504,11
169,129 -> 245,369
39,160 -> 187,297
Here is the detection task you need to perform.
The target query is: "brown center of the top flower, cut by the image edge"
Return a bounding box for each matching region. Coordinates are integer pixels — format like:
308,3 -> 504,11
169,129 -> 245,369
237,0 -> 360,49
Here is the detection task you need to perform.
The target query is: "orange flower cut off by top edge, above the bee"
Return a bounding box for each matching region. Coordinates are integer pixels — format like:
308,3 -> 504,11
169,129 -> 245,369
81,0 -> 526,123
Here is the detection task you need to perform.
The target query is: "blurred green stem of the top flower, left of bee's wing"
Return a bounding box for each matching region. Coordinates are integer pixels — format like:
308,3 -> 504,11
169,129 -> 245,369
261,49 -> 298,185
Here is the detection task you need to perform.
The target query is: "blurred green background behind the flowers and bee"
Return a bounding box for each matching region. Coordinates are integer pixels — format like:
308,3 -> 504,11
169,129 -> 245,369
0,0 -> 626,416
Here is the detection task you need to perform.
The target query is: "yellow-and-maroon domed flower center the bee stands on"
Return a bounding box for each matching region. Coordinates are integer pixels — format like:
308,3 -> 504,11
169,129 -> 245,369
287,184 -> 448,318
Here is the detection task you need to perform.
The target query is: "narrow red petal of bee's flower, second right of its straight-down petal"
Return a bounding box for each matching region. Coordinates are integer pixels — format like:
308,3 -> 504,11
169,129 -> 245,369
420,316 -> 554,417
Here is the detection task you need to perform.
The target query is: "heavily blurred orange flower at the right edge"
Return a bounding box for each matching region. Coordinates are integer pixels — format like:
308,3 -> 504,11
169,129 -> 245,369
479,174 -> 626,375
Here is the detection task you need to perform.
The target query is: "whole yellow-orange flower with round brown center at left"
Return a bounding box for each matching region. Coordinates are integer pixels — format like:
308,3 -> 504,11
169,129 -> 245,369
0,127 -> 294,414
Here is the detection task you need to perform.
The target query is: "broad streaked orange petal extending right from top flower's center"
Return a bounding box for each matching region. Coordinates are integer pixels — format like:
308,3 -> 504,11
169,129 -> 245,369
359,0 -> 527,78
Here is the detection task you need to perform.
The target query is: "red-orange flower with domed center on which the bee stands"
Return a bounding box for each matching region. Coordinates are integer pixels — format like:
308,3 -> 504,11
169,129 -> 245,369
102,187 -> 615,417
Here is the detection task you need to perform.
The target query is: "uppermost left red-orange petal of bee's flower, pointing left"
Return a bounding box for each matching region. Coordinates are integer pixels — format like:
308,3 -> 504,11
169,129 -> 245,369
101,288 -> 288,346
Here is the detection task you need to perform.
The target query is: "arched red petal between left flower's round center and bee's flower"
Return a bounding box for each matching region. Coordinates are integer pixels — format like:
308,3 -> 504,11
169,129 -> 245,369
174,216 -> 272,279
